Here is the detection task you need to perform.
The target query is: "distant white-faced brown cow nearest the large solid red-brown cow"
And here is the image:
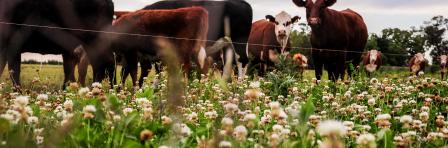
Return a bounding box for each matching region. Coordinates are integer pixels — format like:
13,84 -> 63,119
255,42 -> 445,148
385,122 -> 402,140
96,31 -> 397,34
362,50 -> 382,77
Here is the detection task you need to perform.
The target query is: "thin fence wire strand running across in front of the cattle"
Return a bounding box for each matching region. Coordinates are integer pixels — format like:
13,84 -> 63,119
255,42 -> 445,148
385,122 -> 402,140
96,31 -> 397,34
0,21 -> 411,57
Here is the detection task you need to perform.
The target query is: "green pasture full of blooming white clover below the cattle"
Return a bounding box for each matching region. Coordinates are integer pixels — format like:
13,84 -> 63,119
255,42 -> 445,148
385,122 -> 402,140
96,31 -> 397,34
0,65 -> 448,148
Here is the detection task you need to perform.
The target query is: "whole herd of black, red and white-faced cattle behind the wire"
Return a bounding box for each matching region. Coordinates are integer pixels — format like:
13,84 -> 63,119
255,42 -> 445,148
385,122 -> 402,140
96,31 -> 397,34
0,0 -> 447,86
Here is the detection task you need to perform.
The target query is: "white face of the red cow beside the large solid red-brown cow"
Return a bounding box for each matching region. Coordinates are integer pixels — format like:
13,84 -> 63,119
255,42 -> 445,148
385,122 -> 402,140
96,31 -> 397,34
266,11 -> 300,54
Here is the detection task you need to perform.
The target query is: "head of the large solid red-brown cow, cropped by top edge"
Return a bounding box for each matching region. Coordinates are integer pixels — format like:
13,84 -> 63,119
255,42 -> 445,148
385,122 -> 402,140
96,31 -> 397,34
293,0 -> 337,27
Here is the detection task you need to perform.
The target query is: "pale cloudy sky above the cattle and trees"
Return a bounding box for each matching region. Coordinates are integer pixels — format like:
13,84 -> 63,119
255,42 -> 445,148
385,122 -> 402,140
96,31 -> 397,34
22,0 -> 448,61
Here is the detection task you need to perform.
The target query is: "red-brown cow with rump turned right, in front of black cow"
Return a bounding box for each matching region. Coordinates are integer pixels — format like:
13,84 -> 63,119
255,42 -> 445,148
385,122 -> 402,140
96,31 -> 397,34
112,7 -> 209,86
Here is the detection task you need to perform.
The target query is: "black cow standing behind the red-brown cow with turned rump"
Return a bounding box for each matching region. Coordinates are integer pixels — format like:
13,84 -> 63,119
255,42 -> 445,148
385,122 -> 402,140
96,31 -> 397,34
143,0 -> 253,78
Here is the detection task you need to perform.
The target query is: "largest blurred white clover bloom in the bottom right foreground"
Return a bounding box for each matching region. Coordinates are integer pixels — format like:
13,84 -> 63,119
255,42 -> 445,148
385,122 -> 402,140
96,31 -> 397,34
317,120 -> 347,136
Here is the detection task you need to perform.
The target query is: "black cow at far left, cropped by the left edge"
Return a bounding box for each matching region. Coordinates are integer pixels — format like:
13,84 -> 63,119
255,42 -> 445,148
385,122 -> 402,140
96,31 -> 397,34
0,0 -> 114,86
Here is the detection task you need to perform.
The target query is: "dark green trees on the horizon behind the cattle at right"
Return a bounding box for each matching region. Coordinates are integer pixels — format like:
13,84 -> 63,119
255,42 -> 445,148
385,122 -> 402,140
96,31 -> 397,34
290,16 -> 448,66
